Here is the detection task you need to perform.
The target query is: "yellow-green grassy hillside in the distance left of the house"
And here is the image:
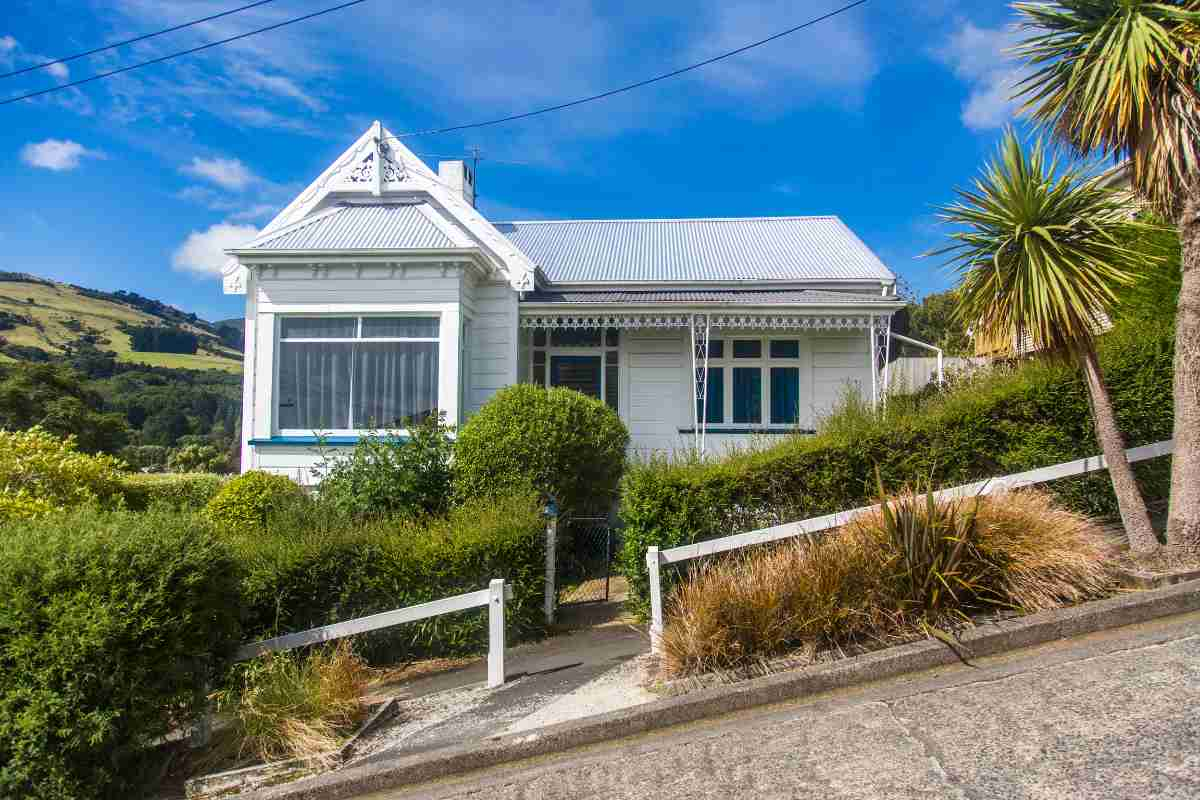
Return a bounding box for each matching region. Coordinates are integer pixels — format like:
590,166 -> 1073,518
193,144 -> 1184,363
0,276 -> 241,373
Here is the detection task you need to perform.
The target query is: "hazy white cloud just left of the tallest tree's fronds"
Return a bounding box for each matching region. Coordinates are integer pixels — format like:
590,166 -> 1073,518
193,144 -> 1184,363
936,22 -> 1028,131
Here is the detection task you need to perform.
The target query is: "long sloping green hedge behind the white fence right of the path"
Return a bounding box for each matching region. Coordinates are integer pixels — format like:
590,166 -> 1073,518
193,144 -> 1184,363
619,320 -> 1174,614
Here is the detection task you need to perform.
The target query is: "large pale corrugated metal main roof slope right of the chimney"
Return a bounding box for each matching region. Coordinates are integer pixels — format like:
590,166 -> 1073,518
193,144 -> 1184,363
496,217 -> 895,283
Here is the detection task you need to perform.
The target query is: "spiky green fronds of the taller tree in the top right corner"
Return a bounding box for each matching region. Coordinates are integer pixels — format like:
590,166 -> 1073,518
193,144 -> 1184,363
1014,0 -> 1200,218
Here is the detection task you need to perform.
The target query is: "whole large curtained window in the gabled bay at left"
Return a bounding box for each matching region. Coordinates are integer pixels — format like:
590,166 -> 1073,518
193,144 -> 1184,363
277,317 -> 440,432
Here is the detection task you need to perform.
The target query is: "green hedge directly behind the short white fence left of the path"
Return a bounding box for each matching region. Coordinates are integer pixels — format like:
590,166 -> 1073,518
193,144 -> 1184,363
227,497 -> 545,660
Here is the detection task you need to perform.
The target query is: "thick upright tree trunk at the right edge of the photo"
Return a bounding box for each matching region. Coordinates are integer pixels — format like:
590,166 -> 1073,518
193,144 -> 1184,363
1166,179 -> 1200,553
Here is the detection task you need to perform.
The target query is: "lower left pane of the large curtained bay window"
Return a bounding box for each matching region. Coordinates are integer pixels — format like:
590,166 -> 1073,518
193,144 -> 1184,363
278,342 -> 354,431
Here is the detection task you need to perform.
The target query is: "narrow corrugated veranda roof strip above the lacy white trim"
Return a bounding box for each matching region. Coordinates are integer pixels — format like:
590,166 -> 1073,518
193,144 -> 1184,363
521,289 -> 899,306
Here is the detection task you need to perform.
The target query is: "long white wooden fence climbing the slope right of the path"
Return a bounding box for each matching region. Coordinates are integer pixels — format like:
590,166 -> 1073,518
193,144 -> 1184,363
646,440 -> 1175,652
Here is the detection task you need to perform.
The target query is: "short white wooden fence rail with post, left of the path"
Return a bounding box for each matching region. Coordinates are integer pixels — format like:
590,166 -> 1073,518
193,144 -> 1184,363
234,578 -> 512,688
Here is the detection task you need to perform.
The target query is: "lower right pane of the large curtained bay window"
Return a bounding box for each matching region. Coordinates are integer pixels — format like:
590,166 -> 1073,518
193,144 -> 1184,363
352,342 -> 438,428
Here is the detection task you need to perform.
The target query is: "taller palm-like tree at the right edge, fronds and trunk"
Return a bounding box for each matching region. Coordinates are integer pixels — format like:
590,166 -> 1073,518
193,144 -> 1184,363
1014,0 -> 1200,552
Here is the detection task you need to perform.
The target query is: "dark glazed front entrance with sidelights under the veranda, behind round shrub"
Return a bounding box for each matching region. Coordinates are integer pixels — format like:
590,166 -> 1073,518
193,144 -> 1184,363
529,327 -> 620,409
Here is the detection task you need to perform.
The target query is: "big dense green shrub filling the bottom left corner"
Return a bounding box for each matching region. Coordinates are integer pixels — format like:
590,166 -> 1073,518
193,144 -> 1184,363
0,509 -> 239,800
